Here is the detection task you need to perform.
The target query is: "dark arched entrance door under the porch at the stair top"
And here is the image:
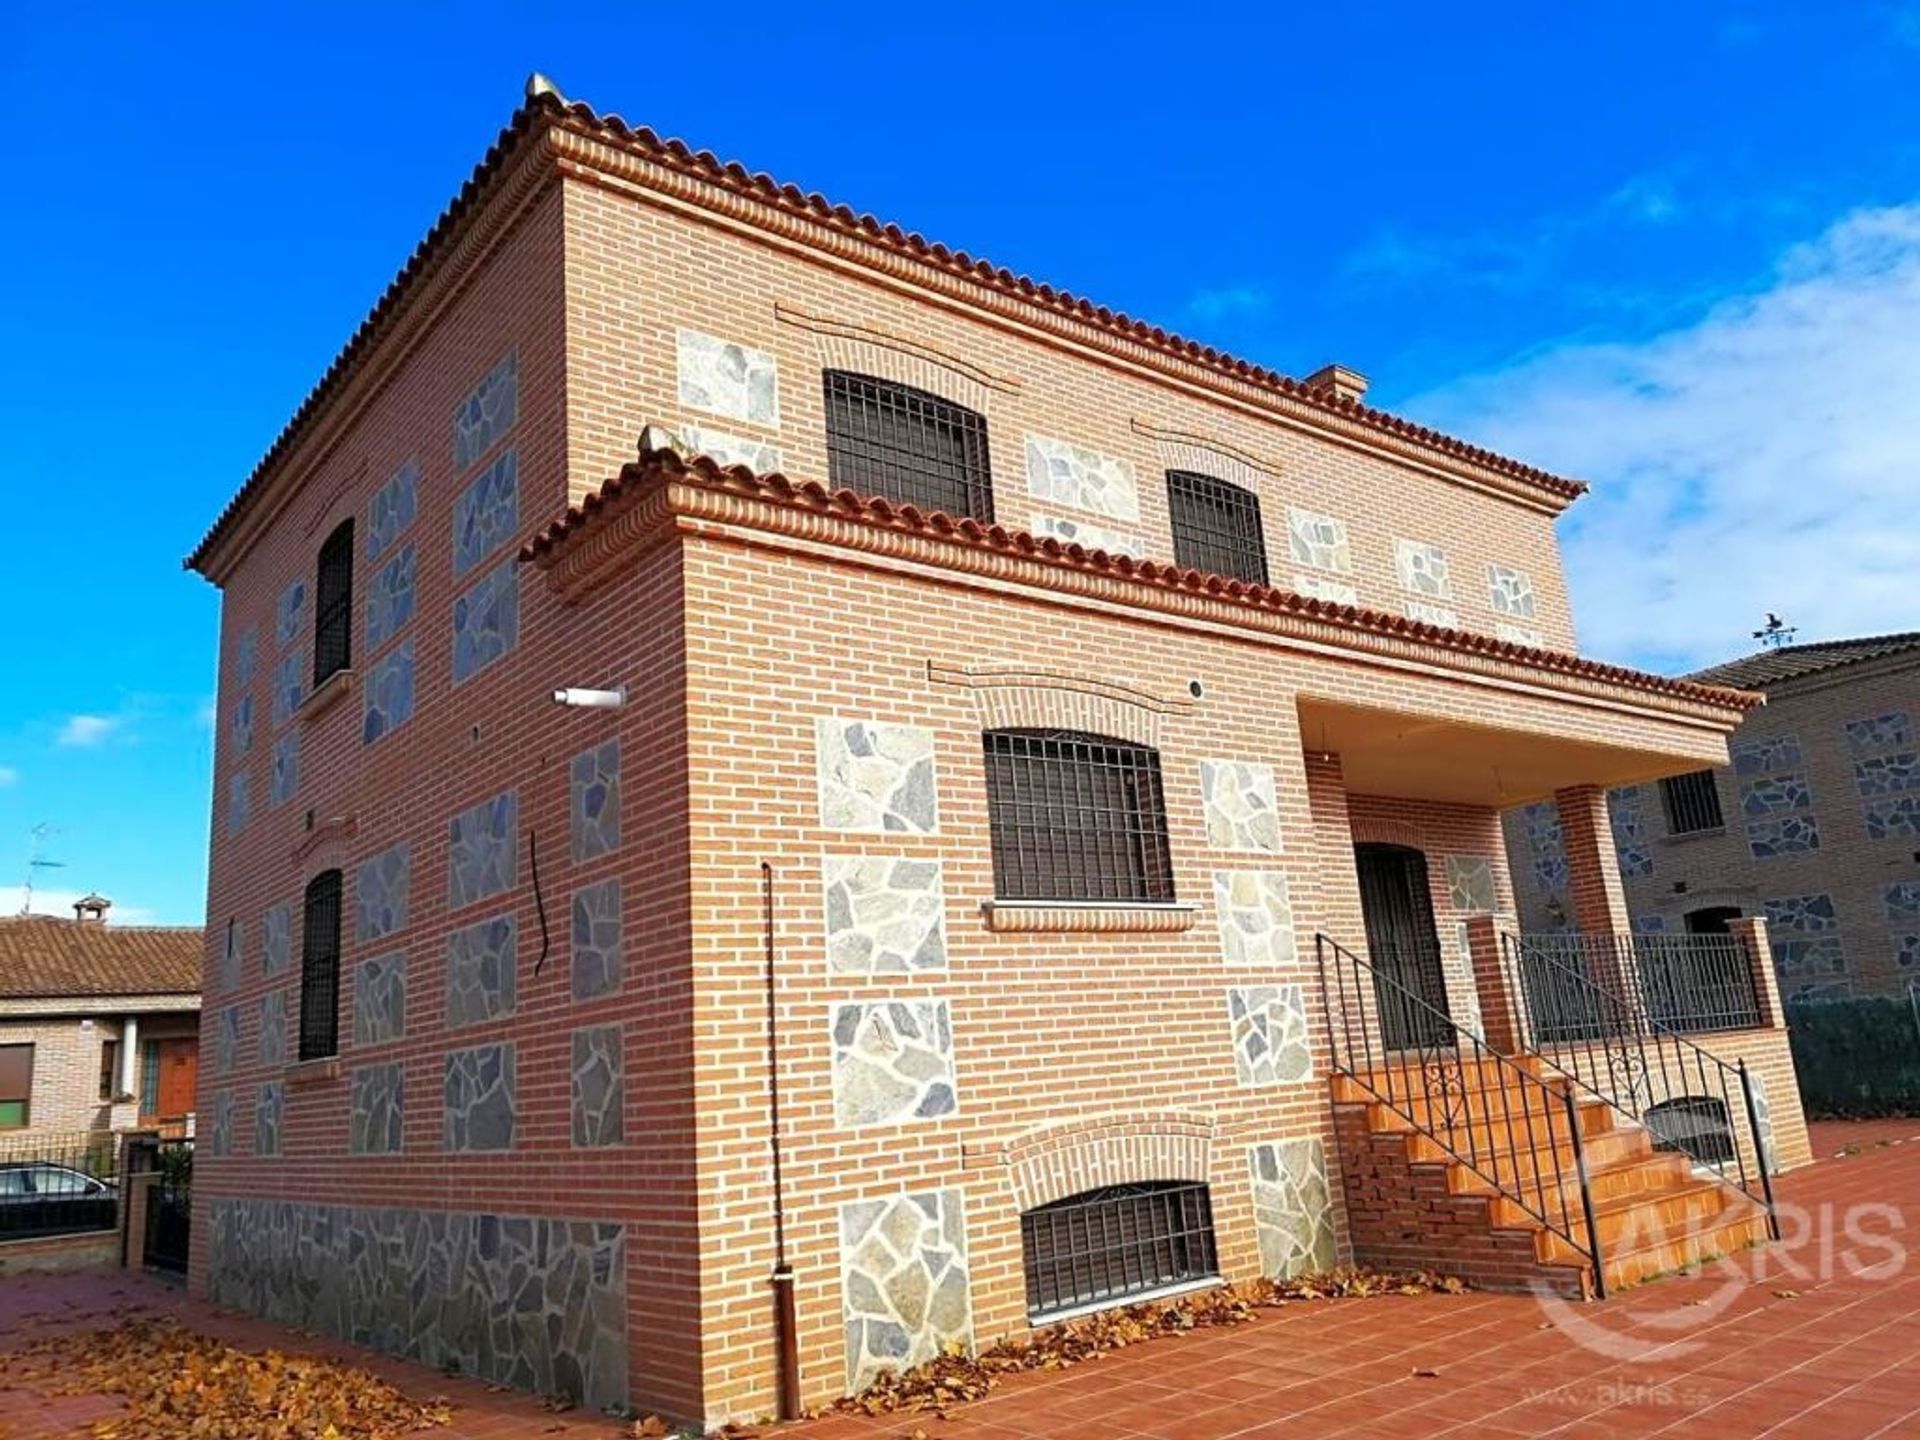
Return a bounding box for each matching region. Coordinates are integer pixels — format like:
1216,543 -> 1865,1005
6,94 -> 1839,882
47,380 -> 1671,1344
1354,845 -> 1453,1050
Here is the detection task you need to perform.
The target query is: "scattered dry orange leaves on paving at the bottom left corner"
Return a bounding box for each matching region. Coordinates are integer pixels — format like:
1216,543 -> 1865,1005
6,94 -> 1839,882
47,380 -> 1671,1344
0,1319 -> 451,1440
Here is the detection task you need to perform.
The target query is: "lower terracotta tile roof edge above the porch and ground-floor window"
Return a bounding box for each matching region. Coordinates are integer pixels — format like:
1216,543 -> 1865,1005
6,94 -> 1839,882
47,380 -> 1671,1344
520,447 -> 1761,710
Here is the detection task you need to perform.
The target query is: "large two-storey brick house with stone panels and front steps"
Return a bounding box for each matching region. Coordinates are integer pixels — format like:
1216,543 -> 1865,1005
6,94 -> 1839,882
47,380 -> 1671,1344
188,81 -> 1807,1421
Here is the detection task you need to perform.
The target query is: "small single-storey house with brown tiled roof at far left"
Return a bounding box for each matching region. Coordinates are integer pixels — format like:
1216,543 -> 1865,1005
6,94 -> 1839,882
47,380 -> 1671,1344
0,895 -> 202,1146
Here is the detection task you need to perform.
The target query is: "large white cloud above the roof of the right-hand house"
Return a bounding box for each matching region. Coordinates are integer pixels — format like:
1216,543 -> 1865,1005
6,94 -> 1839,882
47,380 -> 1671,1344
1405,204 -> 1920,668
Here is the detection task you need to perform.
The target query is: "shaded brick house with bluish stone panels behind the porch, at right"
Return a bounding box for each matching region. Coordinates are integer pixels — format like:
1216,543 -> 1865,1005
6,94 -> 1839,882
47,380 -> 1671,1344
1507,632 -> 1920,1000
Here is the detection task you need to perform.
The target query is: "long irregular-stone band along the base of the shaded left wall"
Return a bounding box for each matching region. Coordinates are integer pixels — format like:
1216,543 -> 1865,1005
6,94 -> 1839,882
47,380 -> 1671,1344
205,1198 -> 632,1409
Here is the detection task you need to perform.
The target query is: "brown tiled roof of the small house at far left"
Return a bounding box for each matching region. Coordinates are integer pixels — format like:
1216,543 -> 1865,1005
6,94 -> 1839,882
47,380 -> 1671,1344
0,916 -> 202,1000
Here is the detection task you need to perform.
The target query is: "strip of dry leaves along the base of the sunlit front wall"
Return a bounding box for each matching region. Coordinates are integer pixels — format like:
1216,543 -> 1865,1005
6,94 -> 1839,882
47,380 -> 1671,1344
835,1267 -> 1467,1415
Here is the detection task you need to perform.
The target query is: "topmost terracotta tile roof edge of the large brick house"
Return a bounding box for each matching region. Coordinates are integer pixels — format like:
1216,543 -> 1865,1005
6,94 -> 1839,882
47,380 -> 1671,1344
184,83 -> 1586,568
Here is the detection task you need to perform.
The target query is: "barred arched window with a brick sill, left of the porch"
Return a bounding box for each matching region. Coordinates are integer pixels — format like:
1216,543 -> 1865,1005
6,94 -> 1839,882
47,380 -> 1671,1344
985,730 -> 1173,900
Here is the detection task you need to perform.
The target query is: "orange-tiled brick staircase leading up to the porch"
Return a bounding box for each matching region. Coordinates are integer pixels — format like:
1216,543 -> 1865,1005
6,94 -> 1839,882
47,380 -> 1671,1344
1332,1052 -> 1768,1296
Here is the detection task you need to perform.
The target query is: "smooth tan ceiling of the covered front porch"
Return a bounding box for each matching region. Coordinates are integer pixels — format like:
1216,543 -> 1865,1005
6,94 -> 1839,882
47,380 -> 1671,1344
1300,695 -> 1726,808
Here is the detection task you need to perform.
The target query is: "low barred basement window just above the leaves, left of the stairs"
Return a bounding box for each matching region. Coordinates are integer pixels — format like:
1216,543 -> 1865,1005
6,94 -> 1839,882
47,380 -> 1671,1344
1020,1181 -> 1219,1315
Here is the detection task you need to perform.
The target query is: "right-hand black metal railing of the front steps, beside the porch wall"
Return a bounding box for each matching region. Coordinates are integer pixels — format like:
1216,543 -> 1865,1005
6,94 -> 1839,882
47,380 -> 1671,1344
1501,933 -> 1780,1240
